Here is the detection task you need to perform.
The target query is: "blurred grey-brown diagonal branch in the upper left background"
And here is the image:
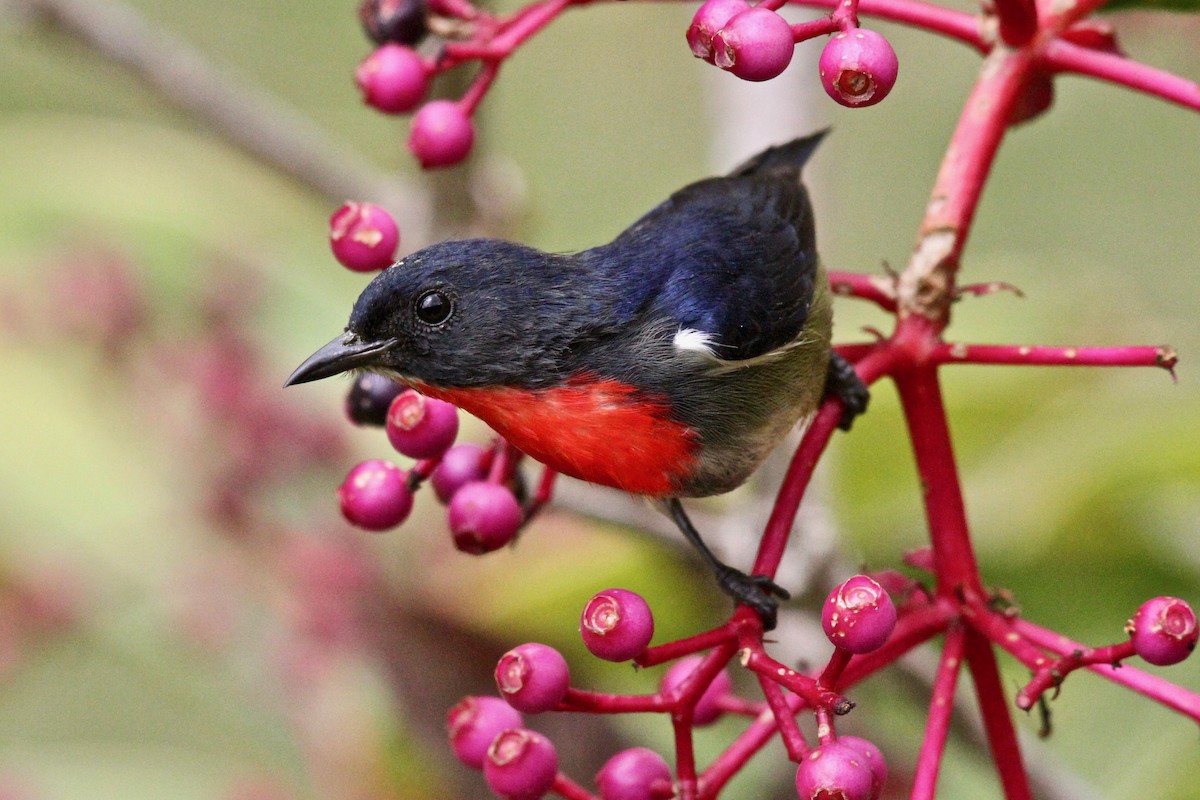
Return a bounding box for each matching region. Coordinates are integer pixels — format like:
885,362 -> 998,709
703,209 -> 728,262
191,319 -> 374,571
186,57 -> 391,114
12,0 -> 433,246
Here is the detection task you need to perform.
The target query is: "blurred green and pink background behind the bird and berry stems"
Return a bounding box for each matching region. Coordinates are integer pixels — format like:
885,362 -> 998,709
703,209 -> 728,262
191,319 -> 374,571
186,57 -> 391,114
0,0 -> 1200,800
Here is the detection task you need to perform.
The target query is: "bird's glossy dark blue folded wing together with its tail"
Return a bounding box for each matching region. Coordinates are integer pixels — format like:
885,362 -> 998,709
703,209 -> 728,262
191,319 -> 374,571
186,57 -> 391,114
594,140 -> 817,361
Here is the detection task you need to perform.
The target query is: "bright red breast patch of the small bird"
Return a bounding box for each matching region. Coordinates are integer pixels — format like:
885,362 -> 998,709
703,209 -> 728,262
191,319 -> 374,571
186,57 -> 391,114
418,375 -> 698,497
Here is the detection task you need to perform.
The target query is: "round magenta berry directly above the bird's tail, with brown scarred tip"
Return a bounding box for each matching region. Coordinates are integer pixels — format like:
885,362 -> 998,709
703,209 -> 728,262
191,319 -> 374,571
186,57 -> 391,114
817,28 -> 900,108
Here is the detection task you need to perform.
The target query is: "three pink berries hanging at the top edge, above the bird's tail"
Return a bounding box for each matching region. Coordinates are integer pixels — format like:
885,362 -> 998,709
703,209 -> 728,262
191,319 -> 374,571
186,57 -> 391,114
688,0 -> 899,108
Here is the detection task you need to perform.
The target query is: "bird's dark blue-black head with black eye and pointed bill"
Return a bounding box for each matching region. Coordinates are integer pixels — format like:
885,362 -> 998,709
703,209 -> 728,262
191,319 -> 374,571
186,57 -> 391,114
288,239 -> 588,386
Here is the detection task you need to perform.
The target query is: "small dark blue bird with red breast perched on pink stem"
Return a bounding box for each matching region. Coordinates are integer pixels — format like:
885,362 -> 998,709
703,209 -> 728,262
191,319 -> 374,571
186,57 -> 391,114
287,132 -> 869,628
